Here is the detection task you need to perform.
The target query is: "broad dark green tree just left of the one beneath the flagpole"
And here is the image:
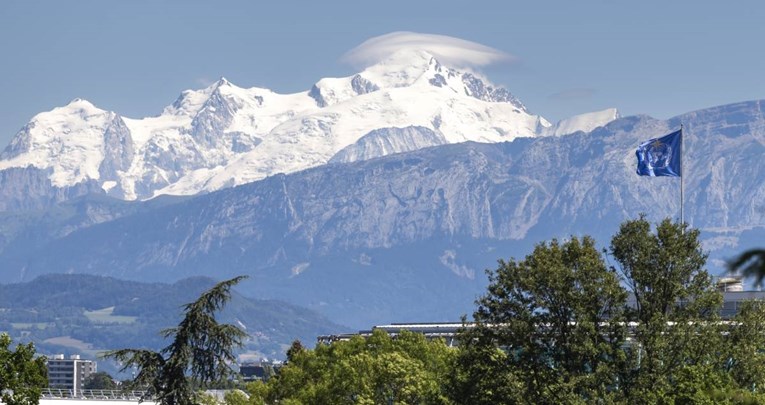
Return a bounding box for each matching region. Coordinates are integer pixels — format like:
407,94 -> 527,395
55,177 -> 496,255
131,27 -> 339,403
453,237 -> 626,403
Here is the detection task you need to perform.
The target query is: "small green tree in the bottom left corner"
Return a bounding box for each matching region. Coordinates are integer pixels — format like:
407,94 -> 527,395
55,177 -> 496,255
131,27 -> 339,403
0,333 -> 48,405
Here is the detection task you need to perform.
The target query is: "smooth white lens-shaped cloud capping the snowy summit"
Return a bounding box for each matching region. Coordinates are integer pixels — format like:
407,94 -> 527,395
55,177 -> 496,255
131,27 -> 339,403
342,31 -> 516,67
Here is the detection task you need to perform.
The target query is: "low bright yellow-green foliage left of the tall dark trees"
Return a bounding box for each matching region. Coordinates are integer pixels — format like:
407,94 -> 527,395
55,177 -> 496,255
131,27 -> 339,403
260,330 -> 455,404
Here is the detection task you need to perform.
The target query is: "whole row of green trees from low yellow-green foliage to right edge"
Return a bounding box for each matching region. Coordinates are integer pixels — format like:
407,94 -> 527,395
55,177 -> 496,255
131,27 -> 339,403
242,217 -> 765,405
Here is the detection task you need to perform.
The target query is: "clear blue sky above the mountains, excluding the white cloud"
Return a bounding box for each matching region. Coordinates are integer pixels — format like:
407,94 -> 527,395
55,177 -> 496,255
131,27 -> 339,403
0,0 -> 765,148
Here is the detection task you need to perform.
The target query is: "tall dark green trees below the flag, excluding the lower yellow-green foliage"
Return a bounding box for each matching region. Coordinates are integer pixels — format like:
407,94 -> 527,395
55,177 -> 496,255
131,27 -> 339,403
449,217 -> 765,404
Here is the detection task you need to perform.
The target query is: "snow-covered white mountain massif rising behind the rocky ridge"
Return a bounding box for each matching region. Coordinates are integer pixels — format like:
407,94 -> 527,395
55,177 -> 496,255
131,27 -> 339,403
0,50 -> 617,207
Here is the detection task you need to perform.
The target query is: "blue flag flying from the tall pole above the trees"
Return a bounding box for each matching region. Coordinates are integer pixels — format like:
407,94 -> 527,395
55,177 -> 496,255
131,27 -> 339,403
636,130 -> 683,177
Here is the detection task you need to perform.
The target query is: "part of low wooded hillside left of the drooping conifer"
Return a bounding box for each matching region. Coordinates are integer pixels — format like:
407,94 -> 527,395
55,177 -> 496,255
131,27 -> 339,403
0,274 -> 221,352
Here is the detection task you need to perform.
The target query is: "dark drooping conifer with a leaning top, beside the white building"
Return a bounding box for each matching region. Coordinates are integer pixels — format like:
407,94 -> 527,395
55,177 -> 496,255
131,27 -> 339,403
105,276 -> 246,405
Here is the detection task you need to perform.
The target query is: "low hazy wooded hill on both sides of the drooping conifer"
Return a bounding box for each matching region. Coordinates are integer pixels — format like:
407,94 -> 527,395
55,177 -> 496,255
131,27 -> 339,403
0,274 -> 346,358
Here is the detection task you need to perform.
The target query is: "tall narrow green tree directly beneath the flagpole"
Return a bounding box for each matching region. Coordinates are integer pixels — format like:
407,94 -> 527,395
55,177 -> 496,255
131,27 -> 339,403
611,216 -> 723,403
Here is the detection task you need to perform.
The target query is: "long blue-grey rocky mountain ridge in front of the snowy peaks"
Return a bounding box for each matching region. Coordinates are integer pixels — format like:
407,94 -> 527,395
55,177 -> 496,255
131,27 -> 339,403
4,101 -> 765,327
